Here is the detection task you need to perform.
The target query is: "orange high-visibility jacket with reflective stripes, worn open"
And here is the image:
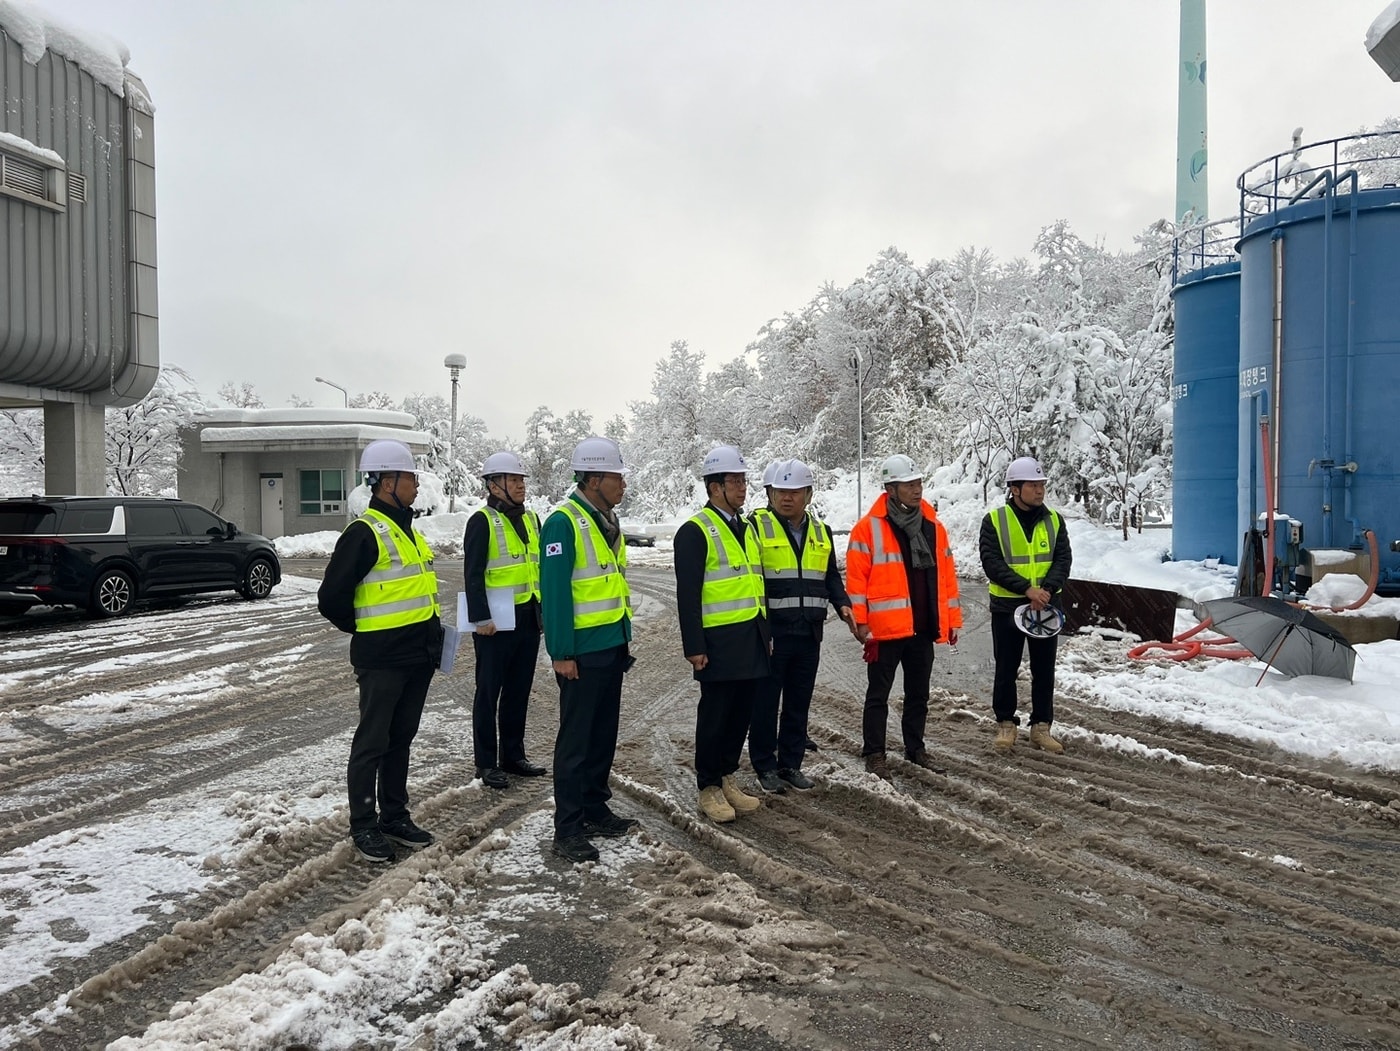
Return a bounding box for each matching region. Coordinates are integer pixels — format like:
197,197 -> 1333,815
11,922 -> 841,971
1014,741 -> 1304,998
846,494 -> 962,642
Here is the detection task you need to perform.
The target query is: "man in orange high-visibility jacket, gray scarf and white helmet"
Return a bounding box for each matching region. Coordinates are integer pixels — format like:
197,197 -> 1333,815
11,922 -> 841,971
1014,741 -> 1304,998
846,455 -> 962,780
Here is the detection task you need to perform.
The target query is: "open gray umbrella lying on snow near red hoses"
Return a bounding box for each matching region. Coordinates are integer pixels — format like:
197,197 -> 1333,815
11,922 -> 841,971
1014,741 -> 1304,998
1203,596 -> 1357,683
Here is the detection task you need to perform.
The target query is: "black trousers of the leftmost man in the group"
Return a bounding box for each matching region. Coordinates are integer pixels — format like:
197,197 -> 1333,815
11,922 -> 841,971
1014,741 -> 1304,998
346,663 -> 437,833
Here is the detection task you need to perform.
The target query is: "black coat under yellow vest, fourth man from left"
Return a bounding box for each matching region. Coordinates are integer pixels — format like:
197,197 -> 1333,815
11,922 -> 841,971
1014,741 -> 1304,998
673,504 -> 771,682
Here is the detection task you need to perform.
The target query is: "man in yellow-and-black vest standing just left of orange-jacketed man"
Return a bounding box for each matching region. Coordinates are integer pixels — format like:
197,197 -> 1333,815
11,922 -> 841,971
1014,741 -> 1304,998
749,460 -> 855,793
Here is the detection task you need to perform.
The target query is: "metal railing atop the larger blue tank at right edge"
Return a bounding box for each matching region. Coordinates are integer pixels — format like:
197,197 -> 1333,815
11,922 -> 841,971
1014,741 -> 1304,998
1235,132 -> 1400,222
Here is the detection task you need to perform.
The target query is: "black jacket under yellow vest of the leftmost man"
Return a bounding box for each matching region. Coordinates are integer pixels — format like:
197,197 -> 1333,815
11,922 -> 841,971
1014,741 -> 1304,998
316,498 -> 442,669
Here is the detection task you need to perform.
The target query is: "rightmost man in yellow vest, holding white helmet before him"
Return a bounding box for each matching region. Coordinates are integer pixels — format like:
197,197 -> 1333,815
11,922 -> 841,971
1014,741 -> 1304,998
977,456 -> 1072,754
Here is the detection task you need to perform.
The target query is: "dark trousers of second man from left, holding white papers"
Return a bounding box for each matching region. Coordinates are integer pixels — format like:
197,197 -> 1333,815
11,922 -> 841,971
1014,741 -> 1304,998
472,630 -> 539,770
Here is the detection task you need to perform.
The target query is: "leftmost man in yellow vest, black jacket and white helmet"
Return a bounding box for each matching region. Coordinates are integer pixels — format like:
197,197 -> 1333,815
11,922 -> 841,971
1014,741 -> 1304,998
316,438 -> 442,862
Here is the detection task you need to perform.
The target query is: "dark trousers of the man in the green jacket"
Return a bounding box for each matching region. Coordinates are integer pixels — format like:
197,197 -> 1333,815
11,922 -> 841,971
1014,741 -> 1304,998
554,645 -> 627,840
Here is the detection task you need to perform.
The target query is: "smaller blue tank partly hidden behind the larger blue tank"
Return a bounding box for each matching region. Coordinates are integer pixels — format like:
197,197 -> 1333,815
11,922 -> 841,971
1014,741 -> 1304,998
1172,262 -> 1240,563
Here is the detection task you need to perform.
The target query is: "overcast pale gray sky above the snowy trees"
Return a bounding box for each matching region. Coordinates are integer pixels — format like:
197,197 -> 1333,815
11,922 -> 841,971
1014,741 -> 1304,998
41,0 -> 1400,437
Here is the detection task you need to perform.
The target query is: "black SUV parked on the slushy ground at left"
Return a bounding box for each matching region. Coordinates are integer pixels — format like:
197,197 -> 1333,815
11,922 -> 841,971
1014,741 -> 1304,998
0,497 -> 281,617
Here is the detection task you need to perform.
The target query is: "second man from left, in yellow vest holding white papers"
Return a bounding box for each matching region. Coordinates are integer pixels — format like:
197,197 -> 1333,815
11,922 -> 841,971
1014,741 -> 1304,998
462,451 -> 547,789
